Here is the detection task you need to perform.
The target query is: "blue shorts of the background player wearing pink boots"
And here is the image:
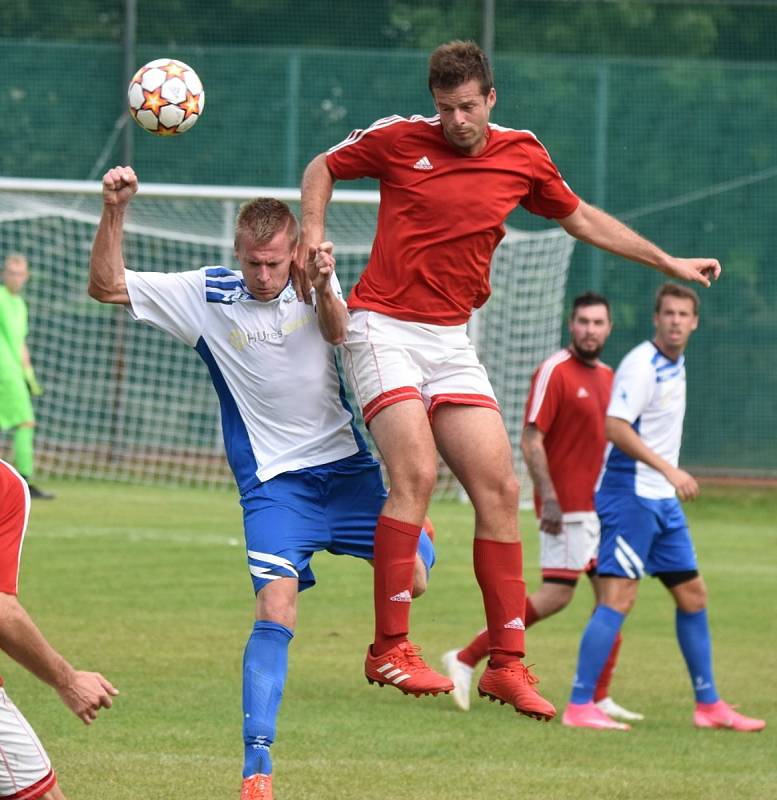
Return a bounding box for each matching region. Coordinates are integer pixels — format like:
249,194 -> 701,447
596,492 -> 697,579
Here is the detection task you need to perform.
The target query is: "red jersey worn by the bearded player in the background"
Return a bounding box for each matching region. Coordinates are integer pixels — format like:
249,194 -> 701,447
524,349 -> 613,517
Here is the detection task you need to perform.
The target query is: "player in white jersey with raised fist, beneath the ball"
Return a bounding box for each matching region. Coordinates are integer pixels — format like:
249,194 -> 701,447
89,167 -> 434,800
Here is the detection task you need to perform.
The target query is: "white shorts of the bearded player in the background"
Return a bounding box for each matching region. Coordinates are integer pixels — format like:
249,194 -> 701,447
540,511 -> 599,580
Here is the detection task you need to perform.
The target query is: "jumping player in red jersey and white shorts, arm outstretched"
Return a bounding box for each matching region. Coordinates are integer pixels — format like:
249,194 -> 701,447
295,42 -> 720,719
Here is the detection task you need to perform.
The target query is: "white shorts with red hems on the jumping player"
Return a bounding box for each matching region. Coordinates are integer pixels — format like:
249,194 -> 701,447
341,309 -> 499,423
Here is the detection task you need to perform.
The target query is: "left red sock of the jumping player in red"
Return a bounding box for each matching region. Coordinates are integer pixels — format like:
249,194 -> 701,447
372,515 -> 421,656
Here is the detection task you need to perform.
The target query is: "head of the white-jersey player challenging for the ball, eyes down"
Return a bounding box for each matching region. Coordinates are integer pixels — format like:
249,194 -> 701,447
235,197 -> 299,301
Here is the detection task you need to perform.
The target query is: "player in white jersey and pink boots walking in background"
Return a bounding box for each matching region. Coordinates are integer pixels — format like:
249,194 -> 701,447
563,283 -> 766,731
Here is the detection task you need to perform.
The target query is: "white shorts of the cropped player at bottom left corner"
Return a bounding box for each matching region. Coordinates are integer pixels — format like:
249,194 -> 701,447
0,688 -> 56,800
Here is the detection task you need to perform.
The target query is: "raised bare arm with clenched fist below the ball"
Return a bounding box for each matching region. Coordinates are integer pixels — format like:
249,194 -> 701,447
88,167 -> 138,305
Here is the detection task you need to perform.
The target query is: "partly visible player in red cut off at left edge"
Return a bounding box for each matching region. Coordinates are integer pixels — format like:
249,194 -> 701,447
0,461 -> 118,800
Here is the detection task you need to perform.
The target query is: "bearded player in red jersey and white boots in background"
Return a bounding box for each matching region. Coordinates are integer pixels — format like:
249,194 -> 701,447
443,292 -> 643,721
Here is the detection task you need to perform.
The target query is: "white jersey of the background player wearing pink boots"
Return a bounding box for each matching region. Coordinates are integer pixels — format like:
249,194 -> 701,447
597,342 -> 685,499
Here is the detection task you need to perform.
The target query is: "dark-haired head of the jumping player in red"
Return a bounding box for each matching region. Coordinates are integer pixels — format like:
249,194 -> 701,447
429,41 -> 496,155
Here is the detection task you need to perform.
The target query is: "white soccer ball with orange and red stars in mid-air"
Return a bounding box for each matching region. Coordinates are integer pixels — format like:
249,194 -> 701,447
127,58 -> 205,136
